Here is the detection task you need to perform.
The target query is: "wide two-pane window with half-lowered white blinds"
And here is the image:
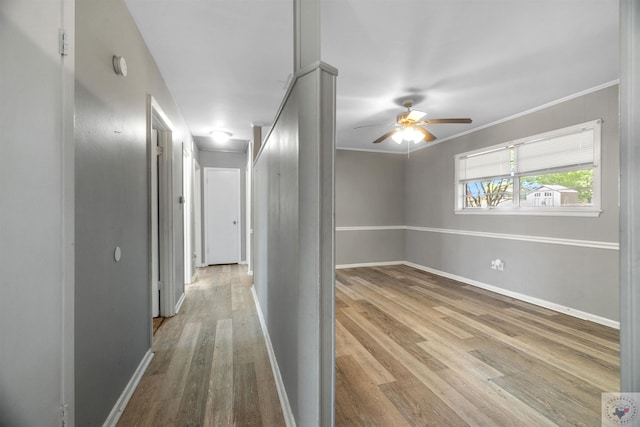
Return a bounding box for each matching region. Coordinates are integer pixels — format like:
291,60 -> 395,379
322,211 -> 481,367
455,120 -> 601,216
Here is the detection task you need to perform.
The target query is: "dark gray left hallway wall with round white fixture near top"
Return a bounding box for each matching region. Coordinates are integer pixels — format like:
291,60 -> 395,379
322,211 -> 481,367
75,0 -> 191,425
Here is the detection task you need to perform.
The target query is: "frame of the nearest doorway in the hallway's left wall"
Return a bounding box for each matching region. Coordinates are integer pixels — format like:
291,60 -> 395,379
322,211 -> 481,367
147,95 -> 176,324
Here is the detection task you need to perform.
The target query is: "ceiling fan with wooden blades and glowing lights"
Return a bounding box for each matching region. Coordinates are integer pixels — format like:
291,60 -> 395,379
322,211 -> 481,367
373,99 -> 471,144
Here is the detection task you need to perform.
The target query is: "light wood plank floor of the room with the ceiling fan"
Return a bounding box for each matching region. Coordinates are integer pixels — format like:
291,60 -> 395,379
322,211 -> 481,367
336,266 -> 619,427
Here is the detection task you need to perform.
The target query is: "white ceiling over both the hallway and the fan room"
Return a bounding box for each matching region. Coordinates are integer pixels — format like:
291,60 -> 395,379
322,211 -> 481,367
125,0 -> 619,152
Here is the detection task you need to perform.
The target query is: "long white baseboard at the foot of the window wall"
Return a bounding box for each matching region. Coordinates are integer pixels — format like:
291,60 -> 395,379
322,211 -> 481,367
403,261 -> 620,329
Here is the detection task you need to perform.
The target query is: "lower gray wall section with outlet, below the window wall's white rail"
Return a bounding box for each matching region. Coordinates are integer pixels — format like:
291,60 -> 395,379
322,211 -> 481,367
406,230 -> 619,321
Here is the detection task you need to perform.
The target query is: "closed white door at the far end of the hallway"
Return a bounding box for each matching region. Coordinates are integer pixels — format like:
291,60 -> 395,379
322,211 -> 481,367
204,168 -> 240,264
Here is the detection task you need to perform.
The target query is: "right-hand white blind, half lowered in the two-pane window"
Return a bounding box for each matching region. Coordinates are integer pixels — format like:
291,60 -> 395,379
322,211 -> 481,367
516,127 -> 595,173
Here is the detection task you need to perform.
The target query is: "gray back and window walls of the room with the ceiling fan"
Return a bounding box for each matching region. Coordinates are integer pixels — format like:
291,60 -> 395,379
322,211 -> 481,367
336,86 -> 619,321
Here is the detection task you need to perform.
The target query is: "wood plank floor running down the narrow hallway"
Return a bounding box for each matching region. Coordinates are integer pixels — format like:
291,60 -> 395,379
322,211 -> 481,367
118,265 -> 284,427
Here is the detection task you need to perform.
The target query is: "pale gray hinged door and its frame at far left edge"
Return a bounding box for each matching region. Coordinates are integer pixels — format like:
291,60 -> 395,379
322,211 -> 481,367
0,0 -> 74,426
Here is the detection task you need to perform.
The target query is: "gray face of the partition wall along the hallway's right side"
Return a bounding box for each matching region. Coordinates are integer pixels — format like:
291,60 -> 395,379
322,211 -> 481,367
254,83 -> 300,422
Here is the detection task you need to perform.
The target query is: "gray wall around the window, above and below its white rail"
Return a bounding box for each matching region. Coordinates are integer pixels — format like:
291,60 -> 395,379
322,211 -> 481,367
405,86 -> 619,321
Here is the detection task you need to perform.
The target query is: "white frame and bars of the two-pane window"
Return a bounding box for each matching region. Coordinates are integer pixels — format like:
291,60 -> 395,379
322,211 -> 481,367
454,119 -> 602,217
